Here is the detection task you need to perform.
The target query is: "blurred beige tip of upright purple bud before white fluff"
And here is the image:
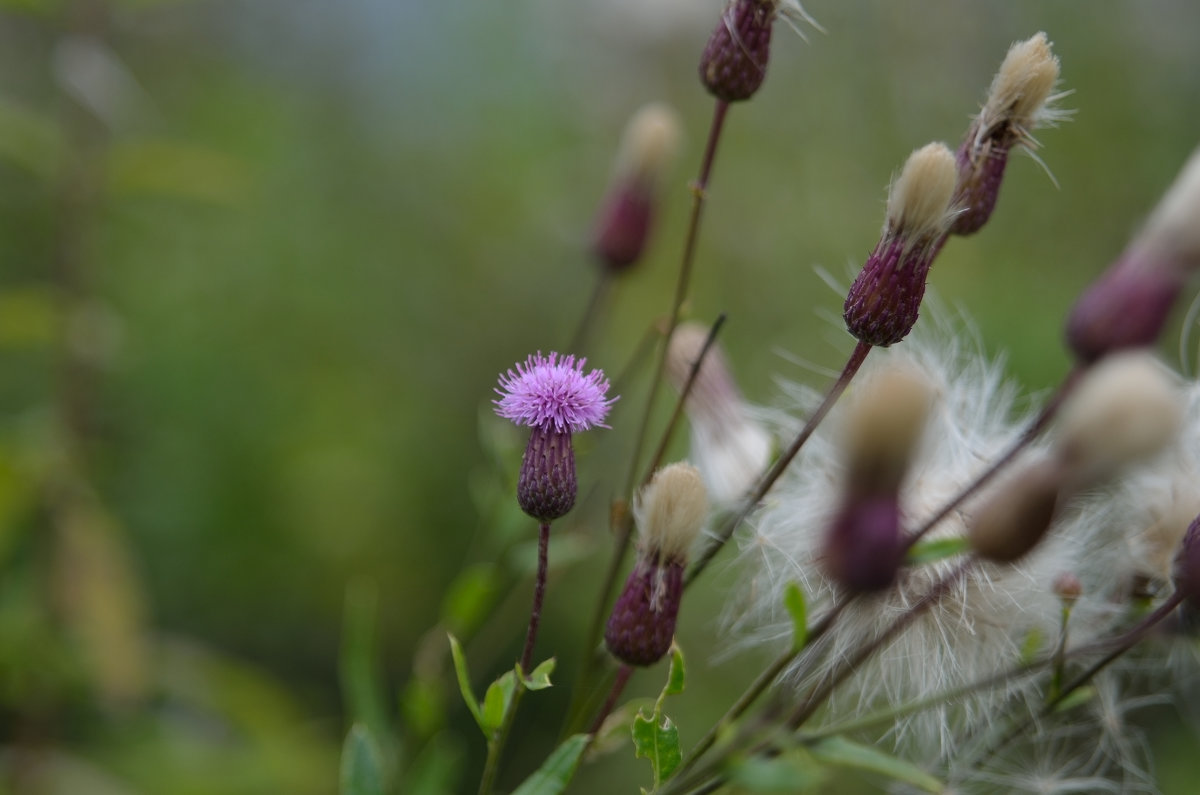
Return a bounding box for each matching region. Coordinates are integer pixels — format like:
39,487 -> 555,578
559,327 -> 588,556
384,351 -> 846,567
845,365 -> 932,492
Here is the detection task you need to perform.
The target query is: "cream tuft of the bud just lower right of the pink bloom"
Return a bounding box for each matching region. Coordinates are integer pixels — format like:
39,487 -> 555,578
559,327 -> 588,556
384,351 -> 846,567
634,462 -> 708,563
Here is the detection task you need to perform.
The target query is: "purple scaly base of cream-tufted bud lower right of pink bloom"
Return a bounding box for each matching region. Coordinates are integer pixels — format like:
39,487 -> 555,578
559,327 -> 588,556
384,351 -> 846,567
604,555 -> 684,665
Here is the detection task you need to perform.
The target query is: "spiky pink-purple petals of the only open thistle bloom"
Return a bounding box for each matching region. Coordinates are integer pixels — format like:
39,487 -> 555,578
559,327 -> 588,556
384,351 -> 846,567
492,351 -> 617,431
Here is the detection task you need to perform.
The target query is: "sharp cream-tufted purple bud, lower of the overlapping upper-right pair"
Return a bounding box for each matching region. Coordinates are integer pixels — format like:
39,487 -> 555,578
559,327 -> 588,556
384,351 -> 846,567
842,143 -> 956,346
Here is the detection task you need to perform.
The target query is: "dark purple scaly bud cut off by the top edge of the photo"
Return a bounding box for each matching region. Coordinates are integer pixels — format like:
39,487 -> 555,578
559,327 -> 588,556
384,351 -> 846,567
700,0 -> 779,102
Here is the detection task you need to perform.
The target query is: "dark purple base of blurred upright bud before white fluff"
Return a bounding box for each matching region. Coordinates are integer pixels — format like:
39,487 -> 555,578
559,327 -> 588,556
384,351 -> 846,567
826,494 -> 904,593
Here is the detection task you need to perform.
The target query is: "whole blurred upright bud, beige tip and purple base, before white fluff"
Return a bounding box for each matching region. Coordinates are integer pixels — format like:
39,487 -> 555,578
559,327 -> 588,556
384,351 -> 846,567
826,367 -> 930,593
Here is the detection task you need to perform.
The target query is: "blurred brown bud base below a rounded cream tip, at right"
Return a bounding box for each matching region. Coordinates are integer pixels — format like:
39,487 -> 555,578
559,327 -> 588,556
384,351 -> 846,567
967,459 -> 1063,563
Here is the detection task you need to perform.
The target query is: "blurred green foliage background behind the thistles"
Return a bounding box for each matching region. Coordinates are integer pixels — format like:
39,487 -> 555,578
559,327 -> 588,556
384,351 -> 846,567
0,0 -> 1200,794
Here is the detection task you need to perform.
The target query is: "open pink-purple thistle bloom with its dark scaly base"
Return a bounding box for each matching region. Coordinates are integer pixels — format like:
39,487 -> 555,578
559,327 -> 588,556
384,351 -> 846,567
493,352 -> 617,521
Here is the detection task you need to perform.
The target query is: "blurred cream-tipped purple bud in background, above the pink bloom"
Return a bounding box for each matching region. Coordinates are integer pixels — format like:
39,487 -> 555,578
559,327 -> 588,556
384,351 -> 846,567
592,103 -> 680,271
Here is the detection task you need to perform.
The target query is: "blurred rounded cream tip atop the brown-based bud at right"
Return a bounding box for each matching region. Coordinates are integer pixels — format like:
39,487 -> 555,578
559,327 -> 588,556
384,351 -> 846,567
1057,351 -> 1183,482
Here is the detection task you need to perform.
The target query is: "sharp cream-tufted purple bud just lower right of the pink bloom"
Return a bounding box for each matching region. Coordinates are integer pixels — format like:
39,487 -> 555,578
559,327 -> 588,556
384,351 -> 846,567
604,464 -> 708,665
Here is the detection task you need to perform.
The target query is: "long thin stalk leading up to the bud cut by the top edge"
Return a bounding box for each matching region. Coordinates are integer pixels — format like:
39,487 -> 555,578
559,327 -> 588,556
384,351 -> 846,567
568,101 -> 730,725
